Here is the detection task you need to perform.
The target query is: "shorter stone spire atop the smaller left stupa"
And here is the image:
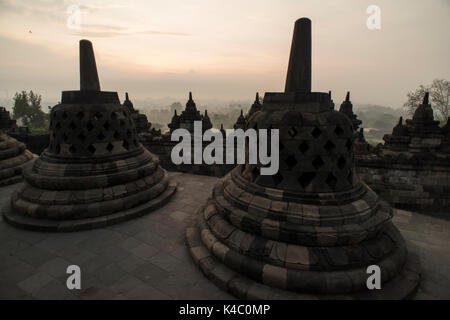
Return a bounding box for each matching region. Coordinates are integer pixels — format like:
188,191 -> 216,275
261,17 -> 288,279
80,40 -> 100,91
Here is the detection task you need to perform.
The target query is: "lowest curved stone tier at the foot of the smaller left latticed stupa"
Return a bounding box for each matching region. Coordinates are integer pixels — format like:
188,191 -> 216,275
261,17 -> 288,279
2,180 -> 177,232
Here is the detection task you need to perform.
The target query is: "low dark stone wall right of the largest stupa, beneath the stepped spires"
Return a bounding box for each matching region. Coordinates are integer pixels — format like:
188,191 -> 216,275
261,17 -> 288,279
357,161 -> 450,217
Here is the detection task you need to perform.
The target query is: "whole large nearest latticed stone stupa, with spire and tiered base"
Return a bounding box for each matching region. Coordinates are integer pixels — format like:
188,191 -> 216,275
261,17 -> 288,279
186,18 -> 420,299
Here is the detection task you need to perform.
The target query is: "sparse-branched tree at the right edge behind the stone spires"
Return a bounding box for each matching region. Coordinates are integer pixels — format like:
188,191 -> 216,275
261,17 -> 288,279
403,79 -> 450,123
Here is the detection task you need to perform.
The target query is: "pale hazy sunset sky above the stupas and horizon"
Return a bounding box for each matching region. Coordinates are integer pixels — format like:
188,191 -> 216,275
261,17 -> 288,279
0,0 -> 450,107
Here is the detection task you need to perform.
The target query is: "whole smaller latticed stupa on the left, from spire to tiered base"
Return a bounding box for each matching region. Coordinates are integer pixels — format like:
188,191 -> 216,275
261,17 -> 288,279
3,40 -> 176,231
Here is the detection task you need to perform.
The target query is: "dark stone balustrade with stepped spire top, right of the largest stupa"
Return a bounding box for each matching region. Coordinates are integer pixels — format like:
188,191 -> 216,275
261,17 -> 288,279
357,93 -> 450,217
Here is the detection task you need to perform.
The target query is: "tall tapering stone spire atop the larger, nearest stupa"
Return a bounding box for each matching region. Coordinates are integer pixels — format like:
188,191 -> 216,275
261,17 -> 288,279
284,18 -> 311,92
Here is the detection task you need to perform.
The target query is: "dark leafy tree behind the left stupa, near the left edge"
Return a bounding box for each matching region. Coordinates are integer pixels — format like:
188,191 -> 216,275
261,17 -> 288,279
13,91 -> 48,128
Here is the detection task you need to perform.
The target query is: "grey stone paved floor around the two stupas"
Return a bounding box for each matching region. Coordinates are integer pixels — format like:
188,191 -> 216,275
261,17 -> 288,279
0,173 -> 450,299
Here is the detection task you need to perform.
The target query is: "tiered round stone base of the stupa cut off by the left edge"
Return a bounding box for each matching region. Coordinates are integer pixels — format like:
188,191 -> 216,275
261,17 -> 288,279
0,129 -> 36,187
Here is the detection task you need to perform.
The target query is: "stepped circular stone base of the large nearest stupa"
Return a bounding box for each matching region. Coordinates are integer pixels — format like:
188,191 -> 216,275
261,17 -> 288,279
186,167 -> 421,299
